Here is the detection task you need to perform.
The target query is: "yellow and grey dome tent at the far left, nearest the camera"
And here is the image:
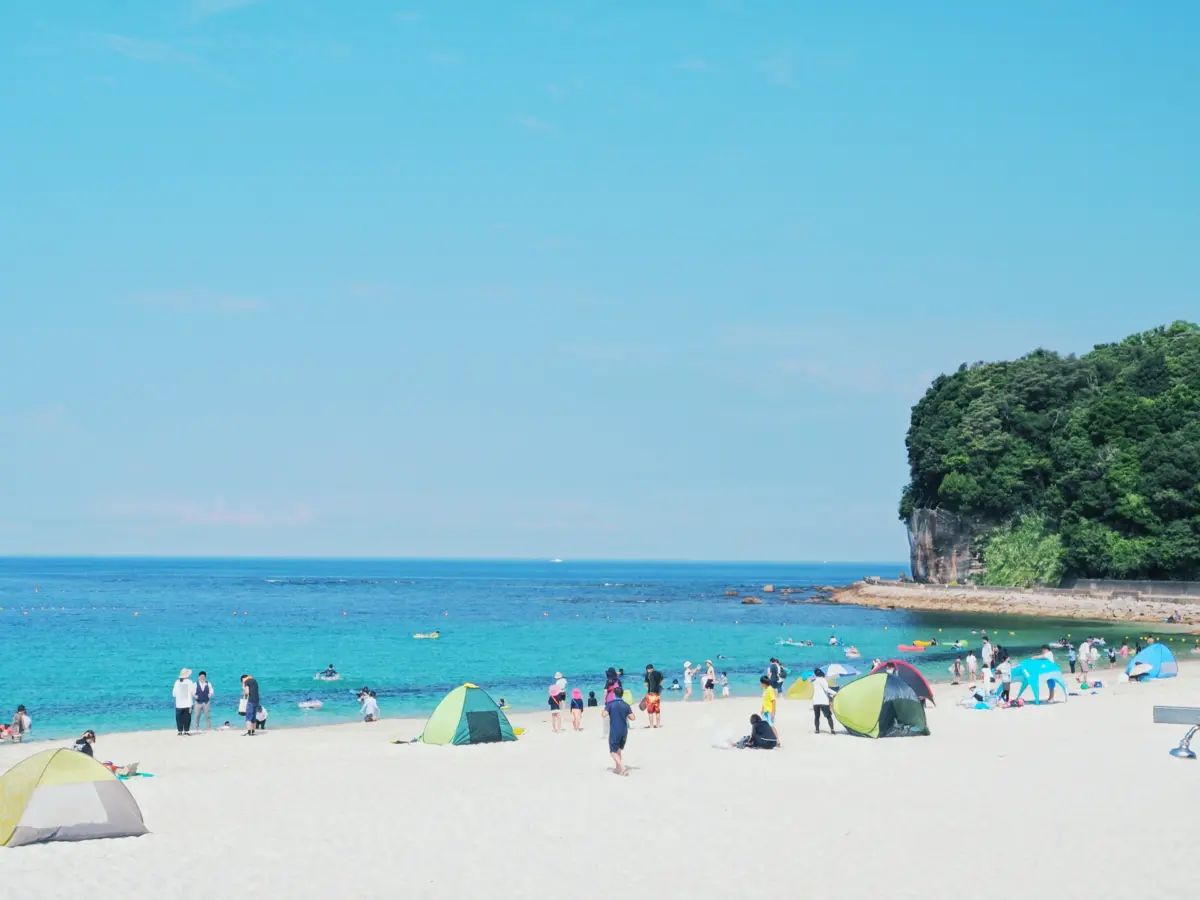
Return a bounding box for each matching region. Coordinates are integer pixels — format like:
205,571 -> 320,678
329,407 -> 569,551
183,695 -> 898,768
0,749 -> 146,847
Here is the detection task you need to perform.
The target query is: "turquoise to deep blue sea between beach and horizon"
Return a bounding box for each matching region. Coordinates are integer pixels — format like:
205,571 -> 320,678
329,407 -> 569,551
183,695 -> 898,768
0,558 -> 1166,739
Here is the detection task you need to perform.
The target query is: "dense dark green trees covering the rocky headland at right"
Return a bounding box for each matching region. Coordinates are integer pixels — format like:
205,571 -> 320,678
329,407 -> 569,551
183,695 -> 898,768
900,322 -> 1200,583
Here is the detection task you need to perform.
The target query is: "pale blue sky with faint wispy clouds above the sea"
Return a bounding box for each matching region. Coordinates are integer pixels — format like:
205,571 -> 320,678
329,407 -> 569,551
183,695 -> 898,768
0,0 -> 1200,560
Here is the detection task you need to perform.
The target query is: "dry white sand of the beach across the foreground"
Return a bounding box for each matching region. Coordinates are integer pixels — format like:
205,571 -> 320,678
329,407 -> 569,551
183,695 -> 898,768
0,666 -> 1200,900
